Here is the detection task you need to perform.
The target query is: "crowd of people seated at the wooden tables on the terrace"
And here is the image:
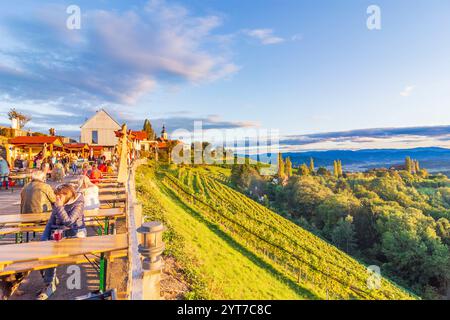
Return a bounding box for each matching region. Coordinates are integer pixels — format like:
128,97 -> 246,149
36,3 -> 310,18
6,154 -> 114,300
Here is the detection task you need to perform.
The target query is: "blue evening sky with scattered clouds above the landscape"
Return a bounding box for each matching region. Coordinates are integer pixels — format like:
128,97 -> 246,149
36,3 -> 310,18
0,0 -> 450,150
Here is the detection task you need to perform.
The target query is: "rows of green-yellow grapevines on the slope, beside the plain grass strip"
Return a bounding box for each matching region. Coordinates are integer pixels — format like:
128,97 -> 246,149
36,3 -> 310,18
138,168 -> 414,300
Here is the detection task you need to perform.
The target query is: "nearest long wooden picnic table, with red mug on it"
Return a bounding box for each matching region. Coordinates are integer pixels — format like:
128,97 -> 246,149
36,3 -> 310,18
0,234 -> 128,291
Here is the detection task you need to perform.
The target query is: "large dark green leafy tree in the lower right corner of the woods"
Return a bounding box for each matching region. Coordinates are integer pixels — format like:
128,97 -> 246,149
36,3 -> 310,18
377,208 -> 450,291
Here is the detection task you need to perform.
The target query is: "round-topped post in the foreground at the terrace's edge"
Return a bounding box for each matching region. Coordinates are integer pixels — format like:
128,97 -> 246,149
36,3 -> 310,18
137,221 -> 165,300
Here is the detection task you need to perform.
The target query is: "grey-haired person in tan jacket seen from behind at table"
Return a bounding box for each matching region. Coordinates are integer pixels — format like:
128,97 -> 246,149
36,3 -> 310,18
20,170 -> 56,213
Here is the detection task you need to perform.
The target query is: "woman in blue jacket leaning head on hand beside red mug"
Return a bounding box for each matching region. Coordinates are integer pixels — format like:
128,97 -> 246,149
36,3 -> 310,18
37,184 -> 87,300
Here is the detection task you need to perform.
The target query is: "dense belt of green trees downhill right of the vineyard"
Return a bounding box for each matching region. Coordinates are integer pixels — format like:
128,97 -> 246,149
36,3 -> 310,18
231,155 -> 450,298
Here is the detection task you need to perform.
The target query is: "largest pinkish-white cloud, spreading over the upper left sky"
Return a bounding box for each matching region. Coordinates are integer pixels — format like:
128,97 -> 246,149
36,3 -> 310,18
0,0 -> 239,105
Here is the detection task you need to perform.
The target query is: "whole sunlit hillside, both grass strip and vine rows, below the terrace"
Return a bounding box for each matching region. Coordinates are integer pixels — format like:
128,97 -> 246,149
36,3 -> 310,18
136,162 -> 414,299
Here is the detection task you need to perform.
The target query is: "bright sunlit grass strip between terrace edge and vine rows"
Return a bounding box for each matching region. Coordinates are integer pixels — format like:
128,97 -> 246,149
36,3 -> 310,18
137,162 -> 313,299
